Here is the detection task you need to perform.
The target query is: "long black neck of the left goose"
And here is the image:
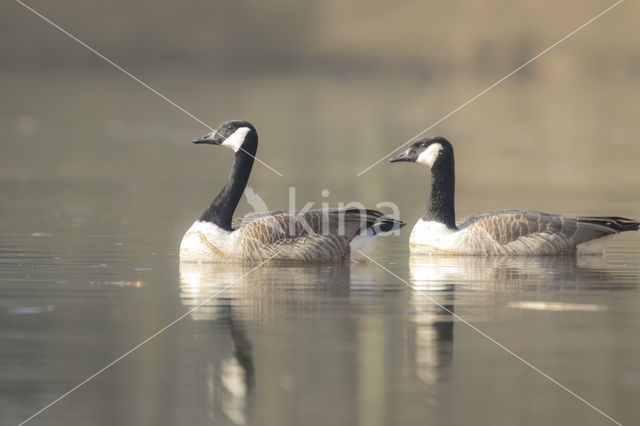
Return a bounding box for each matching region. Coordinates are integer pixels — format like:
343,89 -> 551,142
200,138 -> 258,231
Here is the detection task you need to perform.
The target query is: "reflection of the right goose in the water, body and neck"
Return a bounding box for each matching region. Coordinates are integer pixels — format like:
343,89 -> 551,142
407,255 -> 638,390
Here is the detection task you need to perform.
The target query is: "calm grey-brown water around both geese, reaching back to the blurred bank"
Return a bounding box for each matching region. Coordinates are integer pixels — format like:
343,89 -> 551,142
0,65 -> 640,426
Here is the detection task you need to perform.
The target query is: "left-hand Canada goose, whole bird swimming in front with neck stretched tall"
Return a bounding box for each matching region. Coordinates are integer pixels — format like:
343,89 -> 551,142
180,121 -> 405,262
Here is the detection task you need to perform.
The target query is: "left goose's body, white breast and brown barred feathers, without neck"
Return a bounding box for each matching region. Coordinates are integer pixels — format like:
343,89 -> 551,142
181,209 -> 405,261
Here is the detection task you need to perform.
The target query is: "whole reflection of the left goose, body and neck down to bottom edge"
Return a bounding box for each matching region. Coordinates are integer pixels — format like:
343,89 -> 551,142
180,263 -> 362,424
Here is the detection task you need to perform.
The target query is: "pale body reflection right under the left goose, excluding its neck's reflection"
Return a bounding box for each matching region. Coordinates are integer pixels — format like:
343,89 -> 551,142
180,262 -> 358,322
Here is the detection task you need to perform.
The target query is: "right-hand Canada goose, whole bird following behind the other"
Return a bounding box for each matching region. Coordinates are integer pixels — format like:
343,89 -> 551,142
390,136 -> 640,255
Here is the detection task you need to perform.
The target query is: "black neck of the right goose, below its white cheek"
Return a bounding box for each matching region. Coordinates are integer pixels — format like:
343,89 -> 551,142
422,156 -> 456,229
